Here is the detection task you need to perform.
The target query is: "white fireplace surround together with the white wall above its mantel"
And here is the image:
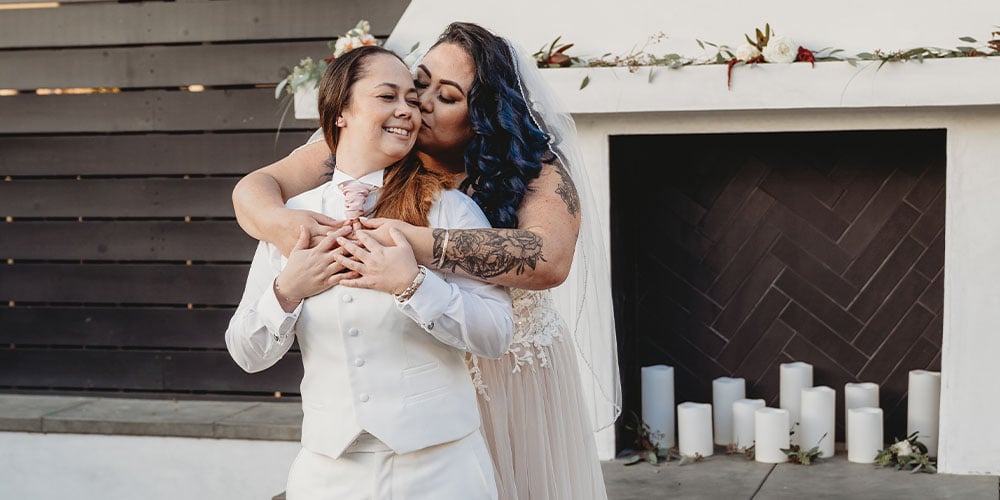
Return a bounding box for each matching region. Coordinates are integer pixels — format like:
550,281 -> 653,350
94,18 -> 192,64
388,0 -> 1000,475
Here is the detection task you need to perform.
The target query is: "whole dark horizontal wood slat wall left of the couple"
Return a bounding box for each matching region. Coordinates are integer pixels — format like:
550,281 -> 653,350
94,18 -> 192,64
0,0 -> 408,399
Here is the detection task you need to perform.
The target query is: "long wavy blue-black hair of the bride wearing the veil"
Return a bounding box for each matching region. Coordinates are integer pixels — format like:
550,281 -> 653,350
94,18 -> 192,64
434,22 -> 555,228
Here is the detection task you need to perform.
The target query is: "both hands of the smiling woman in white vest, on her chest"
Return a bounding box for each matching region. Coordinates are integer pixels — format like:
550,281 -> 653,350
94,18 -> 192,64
276,224 -> 418,301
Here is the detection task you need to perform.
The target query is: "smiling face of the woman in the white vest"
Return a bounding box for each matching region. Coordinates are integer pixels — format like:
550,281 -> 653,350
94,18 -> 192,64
336,54 -> 420,167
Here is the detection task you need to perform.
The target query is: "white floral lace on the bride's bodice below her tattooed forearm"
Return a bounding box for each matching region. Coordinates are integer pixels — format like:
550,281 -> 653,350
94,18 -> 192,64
468,288 -> 565,401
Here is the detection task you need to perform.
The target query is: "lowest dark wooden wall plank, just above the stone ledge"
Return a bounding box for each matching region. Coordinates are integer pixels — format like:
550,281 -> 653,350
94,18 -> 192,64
0,348 -> 302,393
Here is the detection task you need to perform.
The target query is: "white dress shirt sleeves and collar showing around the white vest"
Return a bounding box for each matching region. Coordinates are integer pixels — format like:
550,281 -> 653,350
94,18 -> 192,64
226,170 -> 514,372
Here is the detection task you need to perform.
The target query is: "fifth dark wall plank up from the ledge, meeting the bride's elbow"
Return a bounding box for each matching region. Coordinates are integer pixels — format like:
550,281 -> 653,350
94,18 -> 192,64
0,177 -> 238,217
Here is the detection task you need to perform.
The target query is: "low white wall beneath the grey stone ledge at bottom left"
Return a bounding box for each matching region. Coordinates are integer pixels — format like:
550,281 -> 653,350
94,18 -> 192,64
0,432 -> 299,500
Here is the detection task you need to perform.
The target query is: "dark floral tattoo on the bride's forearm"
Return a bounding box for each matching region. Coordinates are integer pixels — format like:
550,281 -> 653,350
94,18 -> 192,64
432,229 -> 545,279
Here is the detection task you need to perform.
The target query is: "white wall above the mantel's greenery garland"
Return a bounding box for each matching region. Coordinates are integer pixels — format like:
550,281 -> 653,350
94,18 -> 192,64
390,0 -> 1000,62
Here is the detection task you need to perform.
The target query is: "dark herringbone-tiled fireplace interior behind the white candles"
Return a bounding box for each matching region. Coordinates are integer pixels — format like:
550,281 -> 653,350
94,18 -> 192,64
611,130 -> 946,446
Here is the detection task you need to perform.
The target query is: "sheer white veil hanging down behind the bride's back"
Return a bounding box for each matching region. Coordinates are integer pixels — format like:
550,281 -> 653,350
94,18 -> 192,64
505,39 -> 622,431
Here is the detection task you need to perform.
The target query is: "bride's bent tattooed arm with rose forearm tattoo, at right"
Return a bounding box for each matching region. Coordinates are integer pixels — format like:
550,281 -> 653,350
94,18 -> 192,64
366,165 -> 580,290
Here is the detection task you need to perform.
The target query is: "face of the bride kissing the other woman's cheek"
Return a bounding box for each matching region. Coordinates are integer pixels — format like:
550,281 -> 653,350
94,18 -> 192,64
415,43 -> 475,162
